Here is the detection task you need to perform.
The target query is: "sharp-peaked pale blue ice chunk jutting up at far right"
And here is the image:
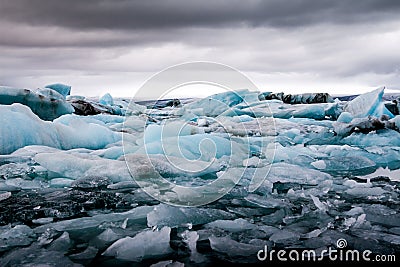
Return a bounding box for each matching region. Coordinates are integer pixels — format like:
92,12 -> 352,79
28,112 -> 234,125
344,87 -> 394,118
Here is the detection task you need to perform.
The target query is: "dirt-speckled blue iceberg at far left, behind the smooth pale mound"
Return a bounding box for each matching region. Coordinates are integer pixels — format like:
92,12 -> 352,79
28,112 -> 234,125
0,86 -> 74,120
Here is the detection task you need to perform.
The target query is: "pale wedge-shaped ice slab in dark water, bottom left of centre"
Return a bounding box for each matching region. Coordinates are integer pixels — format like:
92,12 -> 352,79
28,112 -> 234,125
102,227 -> 171,261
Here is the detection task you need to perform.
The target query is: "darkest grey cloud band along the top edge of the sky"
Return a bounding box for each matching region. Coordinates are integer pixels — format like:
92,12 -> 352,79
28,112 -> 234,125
0,0 -> 400,30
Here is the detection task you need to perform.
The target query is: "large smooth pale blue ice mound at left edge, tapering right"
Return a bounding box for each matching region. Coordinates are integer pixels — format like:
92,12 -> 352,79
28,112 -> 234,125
0,104 -> 121,154
